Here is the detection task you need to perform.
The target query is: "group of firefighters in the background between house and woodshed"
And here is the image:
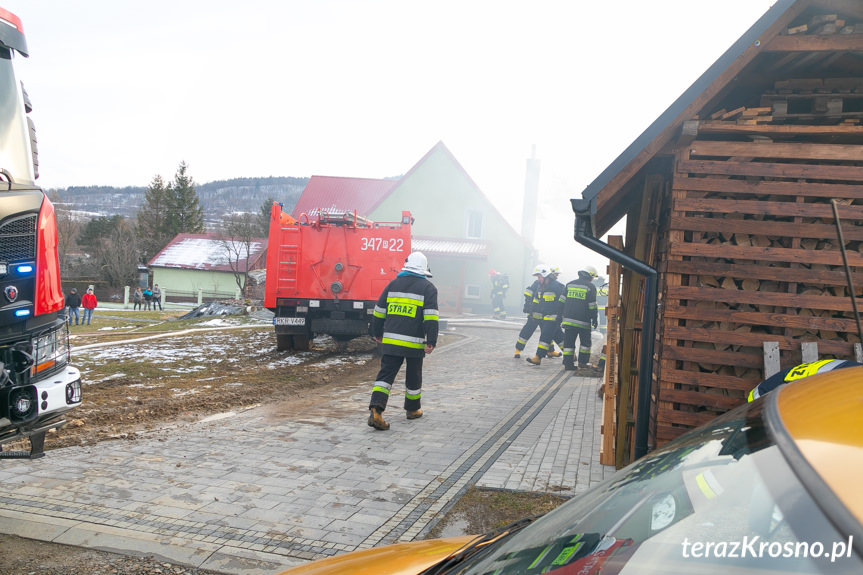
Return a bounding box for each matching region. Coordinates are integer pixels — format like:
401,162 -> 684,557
489,264 -> 599,371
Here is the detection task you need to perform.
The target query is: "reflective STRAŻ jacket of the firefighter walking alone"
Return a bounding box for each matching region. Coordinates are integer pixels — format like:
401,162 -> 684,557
372,272 -> 438,357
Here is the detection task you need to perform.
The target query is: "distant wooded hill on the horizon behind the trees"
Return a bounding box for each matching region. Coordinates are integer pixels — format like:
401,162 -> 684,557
45,176 -> 309,222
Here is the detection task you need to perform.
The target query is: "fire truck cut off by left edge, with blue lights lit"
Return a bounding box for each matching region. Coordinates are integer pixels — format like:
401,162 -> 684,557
0,8 -> 81,458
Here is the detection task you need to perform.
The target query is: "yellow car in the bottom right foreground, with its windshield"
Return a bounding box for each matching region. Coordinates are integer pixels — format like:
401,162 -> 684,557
283,367 -> 863,575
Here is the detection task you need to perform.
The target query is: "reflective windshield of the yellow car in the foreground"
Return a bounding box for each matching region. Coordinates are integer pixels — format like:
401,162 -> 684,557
450,401 -> 863,575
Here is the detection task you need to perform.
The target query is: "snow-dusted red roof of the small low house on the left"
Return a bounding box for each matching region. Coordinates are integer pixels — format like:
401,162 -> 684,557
148,233 -> 267,272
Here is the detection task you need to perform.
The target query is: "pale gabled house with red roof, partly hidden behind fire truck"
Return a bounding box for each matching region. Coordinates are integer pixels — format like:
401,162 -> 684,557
292,142 -> 537,315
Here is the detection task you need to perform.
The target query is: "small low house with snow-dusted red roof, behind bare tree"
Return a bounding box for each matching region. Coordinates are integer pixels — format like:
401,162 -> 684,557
147,233 -> 267,299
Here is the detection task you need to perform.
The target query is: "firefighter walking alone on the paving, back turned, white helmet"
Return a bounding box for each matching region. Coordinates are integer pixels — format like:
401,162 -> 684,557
368,252 -> 438,430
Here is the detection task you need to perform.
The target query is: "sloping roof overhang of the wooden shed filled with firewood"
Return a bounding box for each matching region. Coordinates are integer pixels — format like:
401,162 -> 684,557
573,0 -> 863,237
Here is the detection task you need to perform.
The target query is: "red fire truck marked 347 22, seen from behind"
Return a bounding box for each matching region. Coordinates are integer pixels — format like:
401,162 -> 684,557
264,203 -> 412,351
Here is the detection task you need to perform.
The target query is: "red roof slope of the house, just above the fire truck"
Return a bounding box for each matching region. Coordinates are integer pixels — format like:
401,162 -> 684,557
291,176 -> 399,220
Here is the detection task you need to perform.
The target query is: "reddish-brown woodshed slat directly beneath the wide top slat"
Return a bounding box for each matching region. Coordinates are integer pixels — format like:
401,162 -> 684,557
676,160 -> 863,182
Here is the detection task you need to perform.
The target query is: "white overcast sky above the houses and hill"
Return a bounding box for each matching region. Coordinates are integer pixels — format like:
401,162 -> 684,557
0,0 -> 775,279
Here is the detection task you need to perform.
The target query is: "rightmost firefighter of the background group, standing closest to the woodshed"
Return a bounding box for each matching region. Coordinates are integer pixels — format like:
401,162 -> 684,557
561,266 -> 598,371
